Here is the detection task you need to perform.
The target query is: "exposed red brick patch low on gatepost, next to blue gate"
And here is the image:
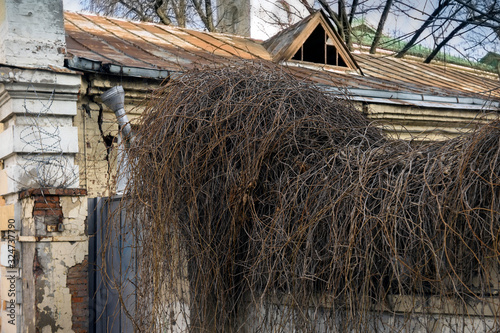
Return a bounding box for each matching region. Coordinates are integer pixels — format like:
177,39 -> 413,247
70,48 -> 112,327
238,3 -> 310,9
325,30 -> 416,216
66,256 -> 89,333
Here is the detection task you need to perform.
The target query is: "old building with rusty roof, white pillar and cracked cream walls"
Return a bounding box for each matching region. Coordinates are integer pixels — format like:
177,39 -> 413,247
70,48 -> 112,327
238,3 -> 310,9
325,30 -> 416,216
0,0 -> 500,332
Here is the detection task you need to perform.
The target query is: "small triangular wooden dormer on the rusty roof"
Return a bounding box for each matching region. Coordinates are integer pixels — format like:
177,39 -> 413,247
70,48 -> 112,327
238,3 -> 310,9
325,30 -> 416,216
263,11 -> 361,74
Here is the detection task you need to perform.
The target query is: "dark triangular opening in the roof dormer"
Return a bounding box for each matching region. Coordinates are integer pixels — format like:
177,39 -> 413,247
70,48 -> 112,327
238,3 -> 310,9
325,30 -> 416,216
292,25 -> 347,67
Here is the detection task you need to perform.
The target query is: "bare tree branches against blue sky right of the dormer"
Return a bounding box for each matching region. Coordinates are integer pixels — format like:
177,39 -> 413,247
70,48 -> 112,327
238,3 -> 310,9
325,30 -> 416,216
296,0 -> 500,62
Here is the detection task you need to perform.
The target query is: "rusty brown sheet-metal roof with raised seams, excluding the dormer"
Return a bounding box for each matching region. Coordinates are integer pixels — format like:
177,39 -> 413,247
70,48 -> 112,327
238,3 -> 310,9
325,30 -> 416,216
65,12 -> 500,103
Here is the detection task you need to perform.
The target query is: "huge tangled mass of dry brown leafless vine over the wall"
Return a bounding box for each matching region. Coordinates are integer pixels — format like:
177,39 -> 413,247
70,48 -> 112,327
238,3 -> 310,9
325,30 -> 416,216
113,64 -> 500,332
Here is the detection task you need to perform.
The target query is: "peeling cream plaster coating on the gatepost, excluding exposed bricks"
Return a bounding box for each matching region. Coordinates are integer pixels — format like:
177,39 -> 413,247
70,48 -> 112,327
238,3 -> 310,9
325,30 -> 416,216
21,196 -> 88,332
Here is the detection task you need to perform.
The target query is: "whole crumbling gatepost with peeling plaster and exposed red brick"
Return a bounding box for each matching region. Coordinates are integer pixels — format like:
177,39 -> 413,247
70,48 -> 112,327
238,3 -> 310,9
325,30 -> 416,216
20,189 -> 88,333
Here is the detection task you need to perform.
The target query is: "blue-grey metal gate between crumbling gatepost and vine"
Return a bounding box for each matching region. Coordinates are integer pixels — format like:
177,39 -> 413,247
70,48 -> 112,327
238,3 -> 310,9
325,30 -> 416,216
88,196 -> 137,333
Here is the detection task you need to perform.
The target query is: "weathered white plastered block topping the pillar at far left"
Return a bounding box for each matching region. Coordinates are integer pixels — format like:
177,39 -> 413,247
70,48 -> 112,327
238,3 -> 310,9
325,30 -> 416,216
0,0 -> 66,68
